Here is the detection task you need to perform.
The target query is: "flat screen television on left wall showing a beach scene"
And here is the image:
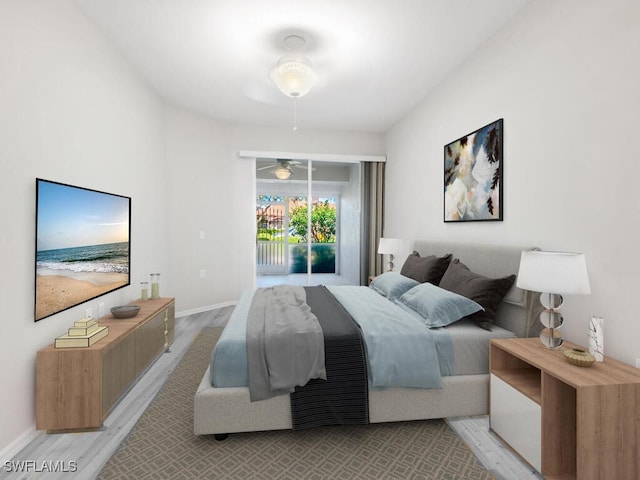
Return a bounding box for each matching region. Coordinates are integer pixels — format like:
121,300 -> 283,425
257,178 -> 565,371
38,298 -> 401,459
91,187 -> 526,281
35,178 -> 131,322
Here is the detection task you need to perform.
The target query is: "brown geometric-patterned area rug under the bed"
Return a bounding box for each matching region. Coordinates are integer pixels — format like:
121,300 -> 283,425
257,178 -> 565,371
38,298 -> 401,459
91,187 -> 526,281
98,327 -> 494,480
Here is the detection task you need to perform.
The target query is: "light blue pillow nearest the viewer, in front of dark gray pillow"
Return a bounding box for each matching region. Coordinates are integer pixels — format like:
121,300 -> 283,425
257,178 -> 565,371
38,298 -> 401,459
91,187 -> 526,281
396,283 -> 484,328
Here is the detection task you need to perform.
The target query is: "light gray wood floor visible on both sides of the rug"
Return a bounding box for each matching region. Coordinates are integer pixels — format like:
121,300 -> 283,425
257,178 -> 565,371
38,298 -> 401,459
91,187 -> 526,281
0,307 -> 542,480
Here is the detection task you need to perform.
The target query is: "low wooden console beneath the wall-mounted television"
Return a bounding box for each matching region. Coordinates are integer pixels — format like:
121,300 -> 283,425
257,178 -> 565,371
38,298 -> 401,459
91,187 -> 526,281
36,298 -> 175,431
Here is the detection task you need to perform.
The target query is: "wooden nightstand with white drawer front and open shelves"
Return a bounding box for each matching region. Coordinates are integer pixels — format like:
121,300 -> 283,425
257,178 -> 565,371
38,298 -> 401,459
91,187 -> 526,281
489,338 -> 640,480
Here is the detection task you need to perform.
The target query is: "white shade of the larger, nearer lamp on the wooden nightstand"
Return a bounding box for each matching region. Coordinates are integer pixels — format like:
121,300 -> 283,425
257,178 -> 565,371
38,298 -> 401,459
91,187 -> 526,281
516,251 -> 591,295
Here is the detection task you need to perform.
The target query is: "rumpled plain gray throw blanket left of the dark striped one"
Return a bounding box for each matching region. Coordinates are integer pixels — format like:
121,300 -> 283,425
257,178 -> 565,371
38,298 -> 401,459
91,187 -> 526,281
247,285 -> 327,402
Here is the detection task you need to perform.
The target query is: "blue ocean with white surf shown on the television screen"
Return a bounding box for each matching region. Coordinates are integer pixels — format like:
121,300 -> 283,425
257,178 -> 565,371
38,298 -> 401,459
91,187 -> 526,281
36,242 -> 129,275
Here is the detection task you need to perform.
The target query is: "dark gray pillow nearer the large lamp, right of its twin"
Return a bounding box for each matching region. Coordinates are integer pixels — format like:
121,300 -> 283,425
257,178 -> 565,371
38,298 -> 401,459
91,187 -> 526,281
440,258 -> 516,322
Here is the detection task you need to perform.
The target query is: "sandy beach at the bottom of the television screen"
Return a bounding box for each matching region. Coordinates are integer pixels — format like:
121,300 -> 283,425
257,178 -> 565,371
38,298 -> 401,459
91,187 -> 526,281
36,269 -> 128,320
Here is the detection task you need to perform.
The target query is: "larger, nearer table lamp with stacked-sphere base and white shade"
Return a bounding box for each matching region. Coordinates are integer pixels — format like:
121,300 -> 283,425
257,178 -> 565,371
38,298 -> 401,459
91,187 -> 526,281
516,250 -> 591,348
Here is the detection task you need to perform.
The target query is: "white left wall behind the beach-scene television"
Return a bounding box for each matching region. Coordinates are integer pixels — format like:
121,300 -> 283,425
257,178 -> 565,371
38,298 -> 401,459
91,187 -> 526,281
0,0 -> 170,460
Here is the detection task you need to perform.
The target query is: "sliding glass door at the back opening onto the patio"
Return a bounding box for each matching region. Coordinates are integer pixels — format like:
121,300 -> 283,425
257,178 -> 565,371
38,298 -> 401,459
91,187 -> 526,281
256,159 -> 360,285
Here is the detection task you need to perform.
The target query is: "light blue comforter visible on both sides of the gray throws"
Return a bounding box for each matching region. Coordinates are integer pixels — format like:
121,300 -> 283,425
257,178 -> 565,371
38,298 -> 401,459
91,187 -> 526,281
211,286 -> 442,388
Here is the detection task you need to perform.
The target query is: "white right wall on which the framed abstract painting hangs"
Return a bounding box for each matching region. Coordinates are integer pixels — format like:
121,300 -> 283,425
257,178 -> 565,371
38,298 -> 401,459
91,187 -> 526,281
385,0 -> 640,364
